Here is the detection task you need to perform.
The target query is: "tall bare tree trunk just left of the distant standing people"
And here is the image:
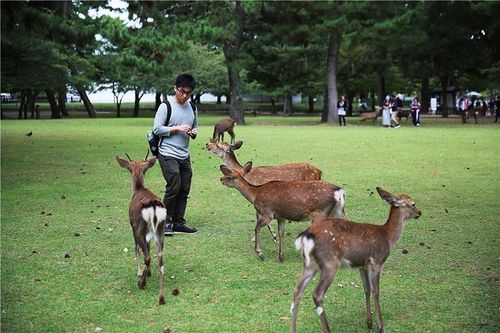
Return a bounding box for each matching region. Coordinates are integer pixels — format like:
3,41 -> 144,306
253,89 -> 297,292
326,31 -> 340,123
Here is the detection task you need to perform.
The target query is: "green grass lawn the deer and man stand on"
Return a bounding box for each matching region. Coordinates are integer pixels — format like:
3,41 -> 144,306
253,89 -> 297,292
1,115 -> 500,333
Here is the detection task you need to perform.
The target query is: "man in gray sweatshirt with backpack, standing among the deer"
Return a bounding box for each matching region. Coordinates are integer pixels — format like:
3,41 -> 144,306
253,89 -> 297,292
153,74 -> 198,236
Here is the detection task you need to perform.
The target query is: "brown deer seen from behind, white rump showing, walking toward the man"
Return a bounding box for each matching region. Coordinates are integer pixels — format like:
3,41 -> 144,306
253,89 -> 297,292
116,150 -> 167,305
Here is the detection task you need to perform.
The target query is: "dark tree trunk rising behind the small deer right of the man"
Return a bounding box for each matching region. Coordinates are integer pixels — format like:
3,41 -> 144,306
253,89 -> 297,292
223,1 -> 245,125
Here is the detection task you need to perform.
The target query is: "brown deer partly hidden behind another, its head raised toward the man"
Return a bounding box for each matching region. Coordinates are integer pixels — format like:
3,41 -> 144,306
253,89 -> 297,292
206,139 -> 321,186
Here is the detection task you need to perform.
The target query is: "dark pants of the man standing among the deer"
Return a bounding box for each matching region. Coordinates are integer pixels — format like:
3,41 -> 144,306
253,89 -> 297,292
158,154 -> 193,224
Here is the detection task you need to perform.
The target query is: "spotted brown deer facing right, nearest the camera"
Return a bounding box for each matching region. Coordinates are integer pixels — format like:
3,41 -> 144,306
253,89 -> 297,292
290,187 -> 422,333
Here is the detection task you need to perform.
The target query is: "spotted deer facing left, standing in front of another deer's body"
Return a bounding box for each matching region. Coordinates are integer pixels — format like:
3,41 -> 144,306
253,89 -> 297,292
220,162 -> 345,262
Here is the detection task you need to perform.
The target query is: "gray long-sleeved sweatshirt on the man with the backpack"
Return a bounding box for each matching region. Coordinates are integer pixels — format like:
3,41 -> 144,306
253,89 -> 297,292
153,98 -> 198,160
